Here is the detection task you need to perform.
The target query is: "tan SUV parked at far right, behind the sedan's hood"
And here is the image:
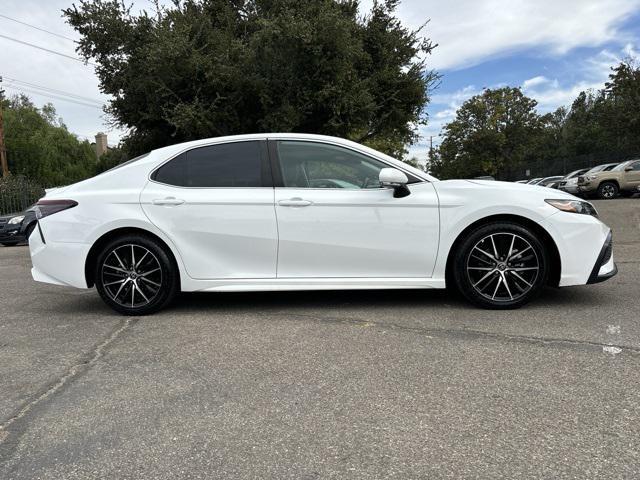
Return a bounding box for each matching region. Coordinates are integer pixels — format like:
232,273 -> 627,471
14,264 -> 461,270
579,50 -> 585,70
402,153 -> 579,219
578,159 -> 640,199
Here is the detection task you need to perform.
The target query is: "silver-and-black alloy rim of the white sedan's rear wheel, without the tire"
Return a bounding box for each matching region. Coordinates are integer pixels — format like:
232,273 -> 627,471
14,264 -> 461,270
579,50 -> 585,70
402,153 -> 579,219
101,244 -> 162,308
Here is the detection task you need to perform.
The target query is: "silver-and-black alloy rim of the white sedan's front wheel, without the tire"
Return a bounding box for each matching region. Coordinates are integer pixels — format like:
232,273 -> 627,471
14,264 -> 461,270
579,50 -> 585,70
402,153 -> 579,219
466,232 -> 540,302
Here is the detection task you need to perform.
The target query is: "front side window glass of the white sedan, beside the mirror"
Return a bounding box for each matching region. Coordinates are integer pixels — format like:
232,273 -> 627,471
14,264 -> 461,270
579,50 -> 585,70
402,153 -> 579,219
277,140 -> 400,189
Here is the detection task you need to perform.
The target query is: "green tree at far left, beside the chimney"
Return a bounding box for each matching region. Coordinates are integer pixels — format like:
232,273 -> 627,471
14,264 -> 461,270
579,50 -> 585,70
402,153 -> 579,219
3,95 -> 95,187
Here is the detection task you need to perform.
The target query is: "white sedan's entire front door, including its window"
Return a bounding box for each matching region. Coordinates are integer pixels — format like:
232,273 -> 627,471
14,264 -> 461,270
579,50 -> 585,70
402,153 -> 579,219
271,140 -> 439,278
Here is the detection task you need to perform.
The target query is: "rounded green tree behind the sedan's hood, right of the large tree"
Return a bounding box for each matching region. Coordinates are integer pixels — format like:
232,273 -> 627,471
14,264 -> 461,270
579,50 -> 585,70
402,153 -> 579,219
430,87 -> 544,178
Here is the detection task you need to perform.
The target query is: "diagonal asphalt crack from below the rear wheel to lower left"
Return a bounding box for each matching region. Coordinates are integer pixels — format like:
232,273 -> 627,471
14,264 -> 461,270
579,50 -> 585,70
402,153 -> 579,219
0,317 -> 137,448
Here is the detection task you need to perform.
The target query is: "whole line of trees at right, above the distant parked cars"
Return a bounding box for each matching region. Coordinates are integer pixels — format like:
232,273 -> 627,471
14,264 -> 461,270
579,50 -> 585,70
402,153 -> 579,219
430,59 -> 640,179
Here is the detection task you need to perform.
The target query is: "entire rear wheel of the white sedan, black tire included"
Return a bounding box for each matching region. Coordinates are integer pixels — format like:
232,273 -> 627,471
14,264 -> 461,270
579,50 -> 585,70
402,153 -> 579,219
94,234 -> 180,315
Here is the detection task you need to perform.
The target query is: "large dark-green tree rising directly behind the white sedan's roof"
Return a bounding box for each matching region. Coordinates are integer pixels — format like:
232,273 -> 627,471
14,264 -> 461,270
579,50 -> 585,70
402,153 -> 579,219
64,0 -> 437,156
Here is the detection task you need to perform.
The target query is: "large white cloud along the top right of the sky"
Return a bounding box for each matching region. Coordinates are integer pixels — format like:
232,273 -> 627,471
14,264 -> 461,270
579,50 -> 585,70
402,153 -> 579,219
361,0 -> 640,70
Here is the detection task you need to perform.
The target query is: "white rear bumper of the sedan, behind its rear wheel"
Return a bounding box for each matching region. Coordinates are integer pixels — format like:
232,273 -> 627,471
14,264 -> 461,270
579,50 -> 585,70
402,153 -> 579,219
29,226 -> 90,288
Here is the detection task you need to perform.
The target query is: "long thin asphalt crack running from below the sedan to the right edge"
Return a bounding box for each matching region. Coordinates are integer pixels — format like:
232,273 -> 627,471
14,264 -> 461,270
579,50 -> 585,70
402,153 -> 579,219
265,312 -> 640,353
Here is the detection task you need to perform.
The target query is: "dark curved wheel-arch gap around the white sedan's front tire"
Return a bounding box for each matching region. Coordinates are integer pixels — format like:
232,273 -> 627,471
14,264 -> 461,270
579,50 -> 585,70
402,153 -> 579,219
445,214 -> 562,287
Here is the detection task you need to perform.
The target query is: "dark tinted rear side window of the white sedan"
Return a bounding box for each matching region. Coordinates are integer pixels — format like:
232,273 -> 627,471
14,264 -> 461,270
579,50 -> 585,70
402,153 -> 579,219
152,141 -> 262,188
